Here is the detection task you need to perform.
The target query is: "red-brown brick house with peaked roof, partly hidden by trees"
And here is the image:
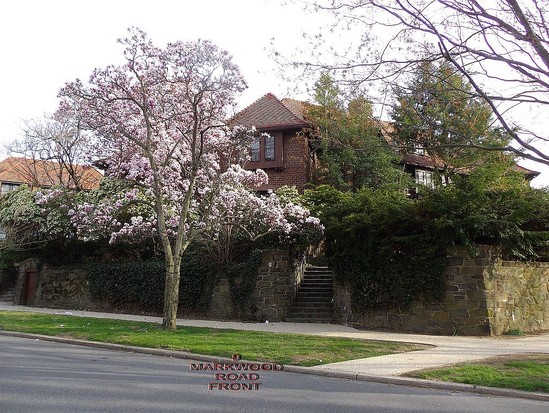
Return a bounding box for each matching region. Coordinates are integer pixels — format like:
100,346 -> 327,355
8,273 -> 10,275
230,93 -> 540,192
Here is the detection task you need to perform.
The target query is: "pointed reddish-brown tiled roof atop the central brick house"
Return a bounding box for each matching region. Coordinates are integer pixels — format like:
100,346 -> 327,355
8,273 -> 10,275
229,93 -> 309,131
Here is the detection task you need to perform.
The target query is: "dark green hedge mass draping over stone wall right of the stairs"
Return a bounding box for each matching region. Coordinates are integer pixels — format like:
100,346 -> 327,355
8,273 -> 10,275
306,180 -> 549,309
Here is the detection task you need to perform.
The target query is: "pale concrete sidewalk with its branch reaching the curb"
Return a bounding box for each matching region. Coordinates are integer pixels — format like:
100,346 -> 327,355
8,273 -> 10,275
0,303 -> 549,377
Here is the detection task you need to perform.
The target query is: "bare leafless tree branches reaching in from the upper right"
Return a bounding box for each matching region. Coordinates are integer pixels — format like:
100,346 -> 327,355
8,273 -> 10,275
298,0 -> 549,165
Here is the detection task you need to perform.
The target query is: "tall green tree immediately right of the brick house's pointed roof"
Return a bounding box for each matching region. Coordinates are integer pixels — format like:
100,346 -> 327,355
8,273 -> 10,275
306,73 -> 406,191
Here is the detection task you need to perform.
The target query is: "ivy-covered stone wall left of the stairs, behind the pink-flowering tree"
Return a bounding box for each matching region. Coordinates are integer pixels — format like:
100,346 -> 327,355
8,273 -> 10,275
23,250 -> 302,321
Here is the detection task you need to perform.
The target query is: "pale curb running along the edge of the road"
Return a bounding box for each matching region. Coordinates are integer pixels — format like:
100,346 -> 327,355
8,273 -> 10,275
0,330 -> 549,402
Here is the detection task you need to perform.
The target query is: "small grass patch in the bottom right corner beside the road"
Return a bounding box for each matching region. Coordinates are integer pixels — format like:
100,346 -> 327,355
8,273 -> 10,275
407,354 -> 549,393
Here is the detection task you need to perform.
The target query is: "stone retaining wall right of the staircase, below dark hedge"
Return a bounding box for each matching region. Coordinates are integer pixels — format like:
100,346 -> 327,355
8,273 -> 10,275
334,247 -> 549,335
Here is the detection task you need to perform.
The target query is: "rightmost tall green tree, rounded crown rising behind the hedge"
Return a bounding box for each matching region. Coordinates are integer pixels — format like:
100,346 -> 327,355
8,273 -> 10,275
392,62 -> 513,183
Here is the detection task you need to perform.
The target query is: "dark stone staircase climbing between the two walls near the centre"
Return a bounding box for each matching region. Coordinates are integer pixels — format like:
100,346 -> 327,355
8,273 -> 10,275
286,267 -> 334,323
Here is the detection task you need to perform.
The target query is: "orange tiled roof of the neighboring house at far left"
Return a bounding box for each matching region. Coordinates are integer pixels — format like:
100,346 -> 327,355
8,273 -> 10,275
0,157 -> 103,189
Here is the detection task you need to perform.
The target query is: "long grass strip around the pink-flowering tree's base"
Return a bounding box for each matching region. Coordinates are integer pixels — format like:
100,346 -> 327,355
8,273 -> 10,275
0,311 -> 428,366
